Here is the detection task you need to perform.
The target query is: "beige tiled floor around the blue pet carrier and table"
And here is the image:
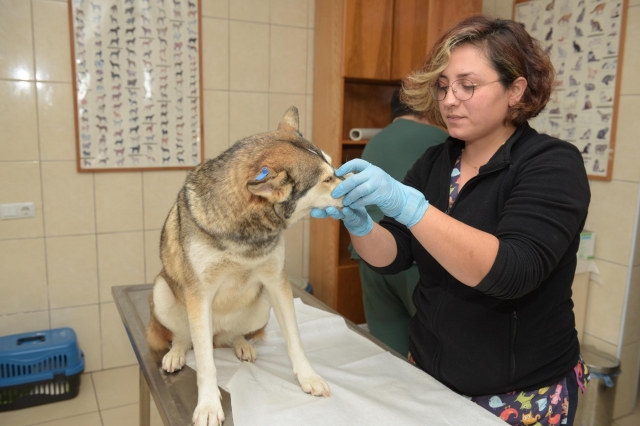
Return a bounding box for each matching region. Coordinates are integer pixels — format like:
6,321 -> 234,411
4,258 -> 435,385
0,365 -> 640,426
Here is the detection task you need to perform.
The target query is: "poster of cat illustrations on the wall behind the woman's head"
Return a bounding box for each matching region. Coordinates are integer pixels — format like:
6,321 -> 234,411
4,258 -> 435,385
514,0 -> 627,180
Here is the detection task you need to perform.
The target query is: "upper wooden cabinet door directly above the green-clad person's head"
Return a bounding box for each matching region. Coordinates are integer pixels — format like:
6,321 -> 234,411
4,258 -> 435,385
391,0 -> 431,80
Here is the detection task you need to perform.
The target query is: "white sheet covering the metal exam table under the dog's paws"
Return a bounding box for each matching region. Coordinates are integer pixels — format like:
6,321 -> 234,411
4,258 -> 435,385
187,299 -> 504,426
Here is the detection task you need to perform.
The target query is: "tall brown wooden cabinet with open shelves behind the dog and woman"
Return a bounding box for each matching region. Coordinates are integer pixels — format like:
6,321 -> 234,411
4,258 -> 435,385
309,0 -> 482,323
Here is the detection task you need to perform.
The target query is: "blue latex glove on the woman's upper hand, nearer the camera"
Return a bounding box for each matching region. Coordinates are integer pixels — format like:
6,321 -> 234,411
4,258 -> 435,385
331,158 -> 429,228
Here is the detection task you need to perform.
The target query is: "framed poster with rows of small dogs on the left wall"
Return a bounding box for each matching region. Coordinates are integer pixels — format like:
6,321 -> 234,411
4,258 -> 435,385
69,0 -> 204,172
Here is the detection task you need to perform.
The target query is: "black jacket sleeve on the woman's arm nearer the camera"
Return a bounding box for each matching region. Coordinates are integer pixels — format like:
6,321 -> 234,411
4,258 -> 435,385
476,141 -> 590,299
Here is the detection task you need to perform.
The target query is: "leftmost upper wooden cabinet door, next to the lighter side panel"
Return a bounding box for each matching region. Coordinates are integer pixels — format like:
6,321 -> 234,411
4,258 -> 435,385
344,0 -> 393,80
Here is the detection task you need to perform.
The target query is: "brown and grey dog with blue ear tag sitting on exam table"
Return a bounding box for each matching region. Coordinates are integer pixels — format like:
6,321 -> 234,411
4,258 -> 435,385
146,107 -> 343,426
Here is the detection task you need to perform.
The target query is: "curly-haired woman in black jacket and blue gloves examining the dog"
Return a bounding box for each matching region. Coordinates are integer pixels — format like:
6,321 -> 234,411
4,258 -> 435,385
312,16 -> 590,425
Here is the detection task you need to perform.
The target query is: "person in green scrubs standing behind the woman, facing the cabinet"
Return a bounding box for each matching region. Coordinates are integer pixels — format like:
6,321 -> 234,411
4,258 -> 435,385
349,89 -> 449,355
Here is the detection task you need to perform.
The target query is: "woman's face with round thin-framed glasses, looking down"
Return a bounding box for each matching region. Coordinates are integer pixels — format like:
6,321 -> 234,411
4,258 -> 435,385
438,44 -> 519,144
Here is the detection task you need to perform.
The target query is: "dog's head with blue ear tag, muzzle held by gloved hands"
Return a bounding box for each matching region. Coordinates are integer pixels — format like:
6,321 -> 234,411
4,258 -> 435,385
246,106 -> 342,226
